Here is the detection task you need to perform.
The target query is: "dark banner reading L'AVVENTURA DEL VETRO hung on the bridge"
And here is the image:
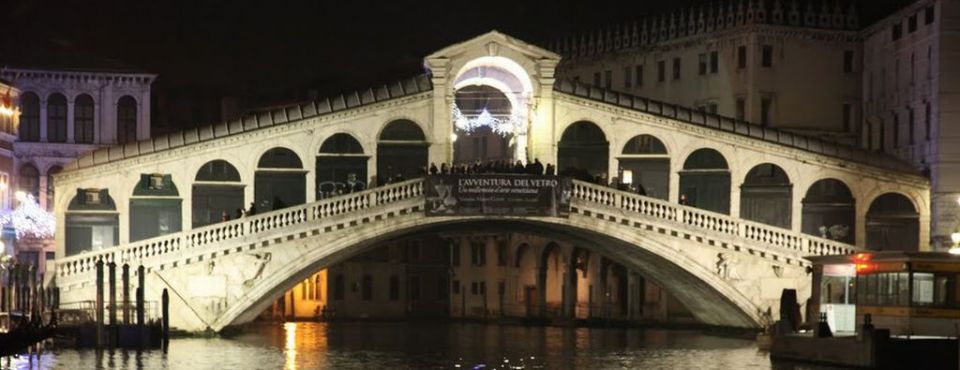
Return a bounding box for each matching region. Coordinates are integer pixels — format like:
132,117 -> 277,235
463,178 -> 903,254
423,174 -> 573,217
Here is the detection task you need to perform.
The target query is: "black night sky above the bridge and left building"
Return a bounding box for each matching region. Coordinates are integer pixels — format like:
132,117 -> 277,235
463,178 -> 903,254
0,0 -> 903,127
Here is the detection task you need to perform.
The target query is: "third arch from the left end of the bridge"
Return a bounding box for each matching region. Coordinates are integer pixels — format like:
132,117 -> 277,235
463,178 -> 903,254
191,159 -> 245,228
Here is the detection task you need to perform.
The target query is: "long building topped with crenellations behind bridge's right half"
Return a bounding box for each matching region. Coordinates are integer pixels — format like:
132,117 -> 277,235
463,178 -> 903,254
553,0 -> 862,143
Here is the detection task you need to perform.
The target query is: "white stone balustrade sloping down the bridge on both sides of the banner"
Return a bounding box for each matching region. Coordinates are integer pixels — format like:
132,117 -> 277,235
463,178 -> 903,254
56,179 -> 859,286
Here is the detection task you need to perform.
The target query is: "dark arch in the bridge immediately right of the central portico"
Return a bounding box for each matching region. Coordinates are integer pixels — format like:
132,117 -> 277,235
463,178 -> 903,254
557,121 -> 609,181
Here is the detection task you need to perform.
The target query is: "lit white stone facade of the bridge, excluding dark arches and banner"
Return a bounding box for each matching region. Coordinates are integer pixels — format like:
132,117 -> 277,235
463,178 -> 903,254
54,32 -> 930,330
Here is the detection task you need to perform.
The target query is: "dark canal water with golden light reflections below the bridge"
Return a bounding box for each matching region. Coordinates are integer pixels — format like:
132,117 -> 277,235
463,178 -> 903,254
0,322 -> 840,370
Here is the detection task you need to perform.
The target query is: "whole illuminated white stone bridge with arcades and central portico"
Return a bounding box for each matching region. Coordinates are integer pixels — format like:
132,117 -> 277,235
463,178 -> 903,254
47,32 -> 930,330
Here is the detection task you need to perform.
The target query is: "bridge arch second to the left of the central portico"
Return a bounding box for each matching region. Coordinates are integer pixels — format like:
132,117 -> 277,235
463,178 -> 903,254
316,133 -> 368,199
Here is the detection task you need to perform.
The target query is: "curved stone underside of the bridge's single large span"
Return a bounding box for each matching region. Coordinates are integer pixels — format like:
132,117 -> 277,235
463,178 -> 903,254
216,216 -> 759,330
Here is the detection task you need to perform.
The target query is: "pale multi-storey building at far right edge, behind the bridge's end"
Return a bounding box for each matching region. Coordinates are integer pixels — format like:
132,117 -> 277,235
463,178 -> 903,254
860,0 -> 960,249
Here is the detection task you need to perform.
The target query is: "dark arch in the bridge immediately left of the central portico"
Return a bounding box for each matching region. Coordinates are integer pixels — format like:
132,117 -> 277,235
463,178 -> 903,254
377,119 -> 428,184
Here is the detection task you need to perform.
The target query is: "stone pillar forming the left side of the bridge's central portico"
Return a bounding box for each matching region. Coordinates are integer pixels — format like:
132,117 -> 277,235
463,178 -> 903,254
427,58 -> 453,166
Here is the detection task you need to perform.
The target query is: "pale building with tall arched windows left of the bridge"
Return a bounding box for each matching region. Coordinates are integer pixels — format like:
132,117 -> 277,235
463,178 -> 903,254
0,67 -> 156,271
